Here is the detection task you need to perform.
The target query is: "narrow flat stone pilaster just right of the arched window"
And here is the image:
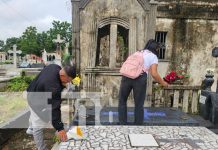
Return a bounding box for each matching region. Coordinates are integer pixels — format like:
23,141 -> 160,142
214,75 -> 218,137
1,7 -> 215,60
129,17 -> 137,54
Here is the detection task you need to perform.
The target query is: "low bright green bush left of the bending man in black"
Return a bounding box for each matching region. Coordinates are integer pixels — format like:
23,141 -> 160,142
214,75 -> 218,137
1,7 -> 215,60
6,76 -> 35,92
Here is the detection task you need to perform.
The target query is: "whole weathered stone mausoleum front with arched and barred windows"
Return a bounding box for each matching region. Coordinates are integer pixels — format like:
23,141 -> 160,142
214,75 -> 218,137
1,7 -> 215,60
72,0 -> 218,105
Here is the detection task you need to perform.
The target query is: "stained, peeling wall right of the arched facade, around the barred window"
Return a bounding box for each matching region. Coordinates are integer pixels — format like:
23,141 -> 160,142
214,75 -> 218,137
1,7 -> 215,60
156,0 -> 218,90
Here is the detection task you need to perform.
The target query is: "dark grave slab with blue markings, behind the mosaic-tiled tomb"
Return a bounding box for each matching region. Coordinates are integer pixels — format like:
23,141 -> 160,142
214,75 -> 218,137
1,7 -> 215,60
71,107 -> 199,126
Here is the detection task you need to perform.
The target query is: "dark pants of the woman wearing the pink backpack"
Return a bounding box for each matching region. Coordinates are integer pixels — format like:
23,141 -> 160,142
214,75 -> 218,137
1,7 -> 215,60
118,73 -> 147,125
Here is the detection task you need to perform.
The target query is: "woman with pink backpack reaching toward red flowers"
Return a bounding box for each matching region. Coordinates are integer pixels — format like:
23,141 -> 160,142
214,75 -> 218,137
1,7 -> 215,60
118,39 -> 168,125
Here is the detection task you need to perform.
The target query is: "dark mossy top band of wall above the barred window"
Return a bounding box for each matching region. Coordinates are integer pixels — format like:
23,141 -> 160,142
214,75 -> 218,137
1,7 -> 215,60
157,0 -> 218,19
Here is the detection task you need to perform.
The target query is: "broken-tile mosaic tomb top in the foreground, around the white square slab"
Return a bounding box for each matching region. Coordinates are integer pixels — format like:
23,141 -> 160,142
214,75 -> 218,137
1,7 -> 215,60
56,126 -> 218,150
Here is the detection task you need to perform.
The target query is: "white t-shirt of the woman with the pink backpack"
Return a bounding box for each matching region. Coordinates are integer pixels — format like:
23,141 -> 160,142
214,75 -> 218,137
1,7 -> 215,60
143,50 -> 158,73
